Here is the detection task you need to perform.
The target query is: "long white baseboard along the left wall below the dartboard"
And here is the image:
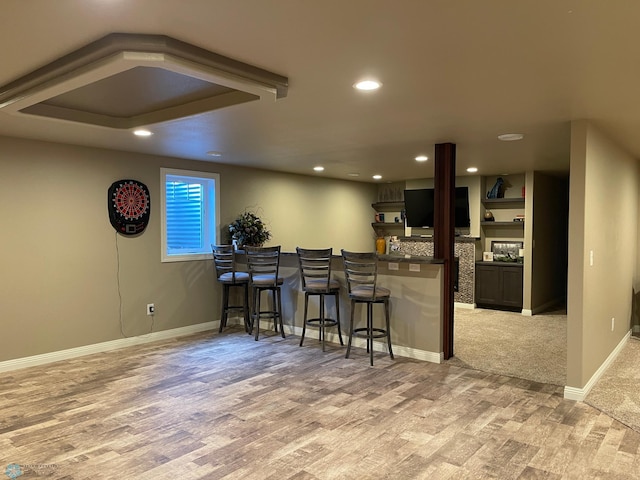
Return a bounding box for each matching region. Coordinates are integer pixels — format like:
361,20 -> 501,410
0,321 -> 220,372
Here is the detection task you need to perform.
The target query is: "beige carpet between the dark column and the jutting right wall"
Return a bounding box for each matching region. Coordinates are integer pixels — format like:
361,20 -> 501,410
448,308 -> 567,386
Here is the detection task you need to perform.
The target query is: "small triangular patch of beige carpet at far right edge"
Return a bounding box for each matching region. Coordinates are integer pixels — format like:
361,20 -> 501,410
585,337 -> 640,432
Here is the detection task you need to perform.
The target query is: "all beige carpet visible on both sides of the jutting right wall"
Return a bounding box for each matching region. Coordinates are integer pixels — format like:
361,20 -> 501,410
448,308 -> 640,432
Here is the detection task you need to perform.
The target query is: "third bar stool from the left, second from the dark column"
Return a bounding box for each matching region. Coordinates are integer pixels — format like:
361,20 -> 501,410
296,247 -> 344,352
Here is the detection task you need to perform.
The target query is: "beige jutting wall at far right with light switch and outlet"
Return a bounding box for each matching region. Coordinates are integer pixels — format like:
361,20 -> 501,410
567,121 -> 640,388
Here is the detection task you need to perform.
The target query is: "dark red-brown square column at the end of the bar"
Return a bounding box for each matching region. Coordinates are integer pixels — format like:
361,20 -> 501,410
433,143 -> 456,359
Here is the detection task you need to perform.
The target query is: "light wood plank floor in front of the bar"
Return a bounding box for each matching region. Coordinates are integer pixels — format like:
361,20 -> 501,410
0,329 -> 640,480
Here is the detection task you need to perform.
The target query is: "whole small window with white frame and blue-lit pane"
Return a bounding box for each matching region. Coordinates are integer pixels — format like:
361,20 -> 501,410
160,168 -> 220,262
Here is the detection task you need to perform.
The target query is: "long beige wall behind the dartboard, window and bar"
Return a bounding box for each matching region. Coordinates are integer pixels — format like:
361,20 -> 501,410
0,138 -> 376,361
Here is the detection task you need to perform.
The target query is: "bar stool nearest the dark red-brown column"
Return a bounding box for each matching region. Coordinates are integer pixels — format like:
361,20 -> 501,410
342,250 -> 393,366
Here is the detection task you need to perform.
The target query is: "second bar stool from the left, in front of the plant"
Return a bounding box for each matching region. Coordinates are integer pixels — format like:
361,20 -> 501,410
244,245 -> 285,341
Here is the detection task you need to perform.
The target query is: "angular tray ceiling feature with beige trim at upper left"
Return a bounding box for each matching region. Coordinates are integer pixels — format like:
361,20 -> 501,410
0,33 -> 288,129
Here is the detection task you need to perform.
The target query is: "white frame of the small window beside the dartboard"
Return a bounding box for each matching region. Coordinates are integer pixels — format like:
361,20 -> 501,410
160,167 -> 220,262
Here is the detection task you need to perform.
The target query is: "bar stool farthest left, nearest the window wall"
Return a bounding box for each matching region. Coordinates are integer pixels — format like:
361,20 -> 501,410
211,245 -> 251,333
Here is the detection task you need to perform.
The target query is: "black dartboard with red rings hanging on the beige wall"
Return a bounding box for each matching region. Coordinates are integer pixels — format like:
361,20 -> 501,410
107,180 -> 151,235
